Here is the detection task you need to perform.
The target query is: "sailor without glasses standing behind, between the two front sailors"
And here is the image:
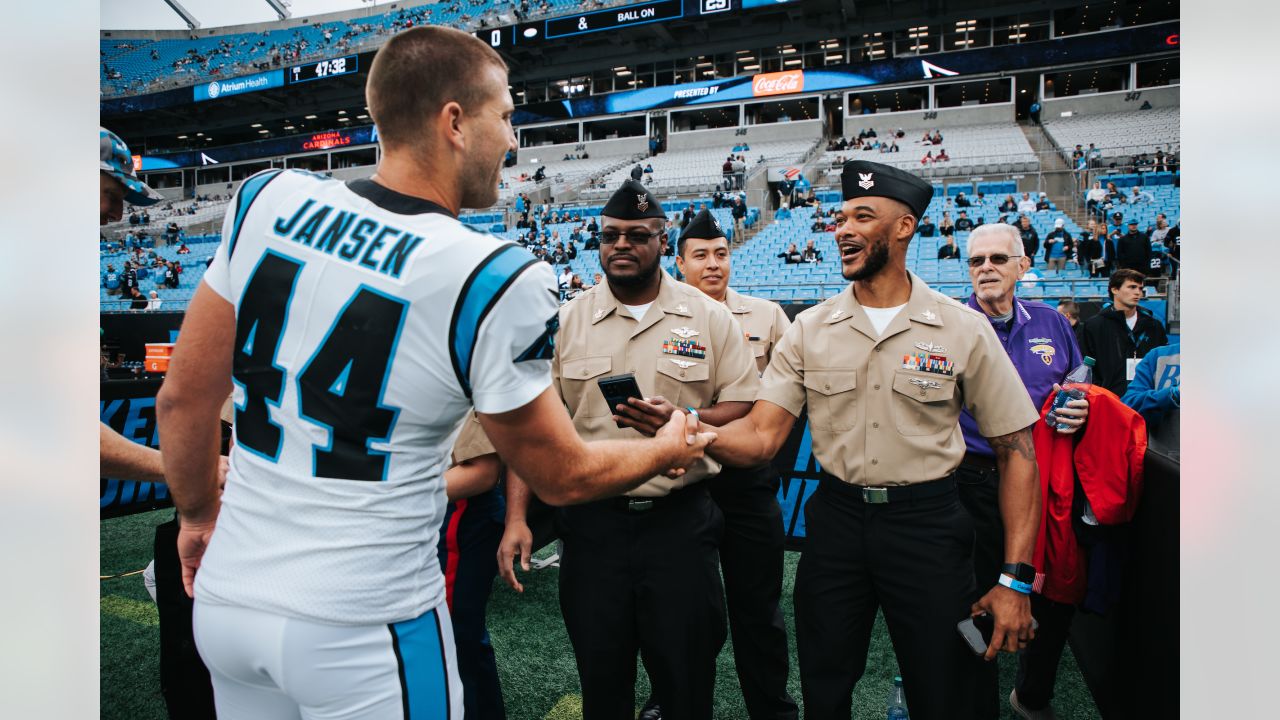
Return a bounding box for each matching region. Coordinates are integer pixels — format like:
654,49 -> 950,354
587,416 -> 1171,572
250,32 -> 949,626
641,209 -> 799,720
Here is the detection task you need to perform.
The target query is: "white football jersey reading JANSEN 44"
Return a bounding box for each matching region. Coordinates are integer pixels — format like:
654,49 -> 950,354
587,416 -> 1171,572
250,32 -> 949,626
196,169 -> 559,625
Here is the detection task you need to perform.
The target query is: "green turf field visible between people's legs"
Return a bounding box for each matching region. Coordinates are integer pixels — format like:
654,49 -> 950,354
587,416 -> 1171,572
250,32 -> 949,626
100,510 -> 1098,720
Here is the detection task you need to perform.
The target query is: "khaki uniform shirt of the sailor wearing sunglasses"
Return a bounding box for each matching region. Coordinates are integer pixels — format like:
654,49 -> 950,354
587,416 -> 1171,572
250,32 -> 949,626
552,273 -> 757,497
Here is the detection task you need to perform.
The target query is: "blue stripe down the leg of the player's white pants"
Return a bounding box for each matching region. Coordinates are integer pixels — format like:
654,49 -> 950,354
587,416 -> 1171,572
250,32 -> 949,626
387,610 -> 451,720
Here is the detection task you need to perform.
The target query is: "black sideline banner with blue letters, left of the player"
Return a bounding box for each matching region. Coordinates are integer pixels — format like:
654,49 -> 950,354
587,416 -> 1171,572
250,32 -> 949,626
99,379 -> 173,520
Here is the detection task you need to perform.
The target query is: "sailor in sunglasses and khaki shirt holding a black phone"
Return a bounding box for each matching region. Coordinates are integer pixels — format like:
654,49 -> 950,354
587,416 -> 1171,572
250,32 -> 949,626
508,181 -> 759,720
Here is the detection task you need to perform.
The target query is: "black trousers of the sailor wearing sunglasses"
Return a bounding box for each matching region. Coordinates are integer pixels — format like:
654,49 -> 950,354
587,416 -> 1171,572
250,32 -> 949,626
559,484 -> 727,720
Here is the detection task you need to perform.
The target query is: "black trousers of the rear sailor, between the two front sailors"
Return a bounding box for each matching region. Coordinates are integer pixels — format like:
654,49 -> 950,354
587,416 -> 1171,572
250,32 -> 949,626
707,465 -> 800,720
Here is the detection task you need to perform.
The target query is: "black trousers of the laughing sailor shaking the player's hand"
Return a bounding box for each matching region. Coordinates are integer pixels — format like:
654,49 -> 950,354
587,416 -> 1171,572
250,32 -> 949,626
795,479 -> 982,720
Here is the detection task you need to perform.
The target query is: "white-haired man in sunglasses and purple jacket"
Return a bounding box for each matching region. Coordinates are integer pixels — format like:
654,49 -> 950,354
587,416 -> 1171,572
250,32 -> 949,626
956,223 -> 1089,720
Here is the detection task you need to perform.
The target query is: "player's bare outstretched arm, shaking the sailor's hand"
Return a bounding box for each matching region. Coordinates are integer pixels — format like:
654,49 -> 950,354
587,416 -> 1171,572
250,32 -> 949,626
477,387 -> 716,505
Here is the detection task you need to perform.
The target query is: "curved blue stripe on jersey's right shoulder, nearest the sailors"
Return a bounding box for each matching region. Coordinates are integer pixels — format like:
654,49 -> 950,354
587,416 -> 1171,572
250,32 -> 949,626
449,243 -> 538,397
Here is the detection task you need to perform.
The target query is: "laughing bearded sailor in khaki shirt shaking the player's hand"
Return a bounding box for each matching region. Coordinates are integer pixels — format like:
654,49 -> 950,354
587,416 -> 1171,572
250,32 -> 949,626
709,160 -> 1039,720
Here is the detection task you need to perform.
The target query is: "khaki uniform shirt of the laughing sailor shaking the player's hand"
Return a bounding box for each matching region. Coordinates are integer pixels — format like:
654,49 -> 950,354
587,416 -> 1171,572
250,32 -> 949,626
759,274 -> 1039,487
